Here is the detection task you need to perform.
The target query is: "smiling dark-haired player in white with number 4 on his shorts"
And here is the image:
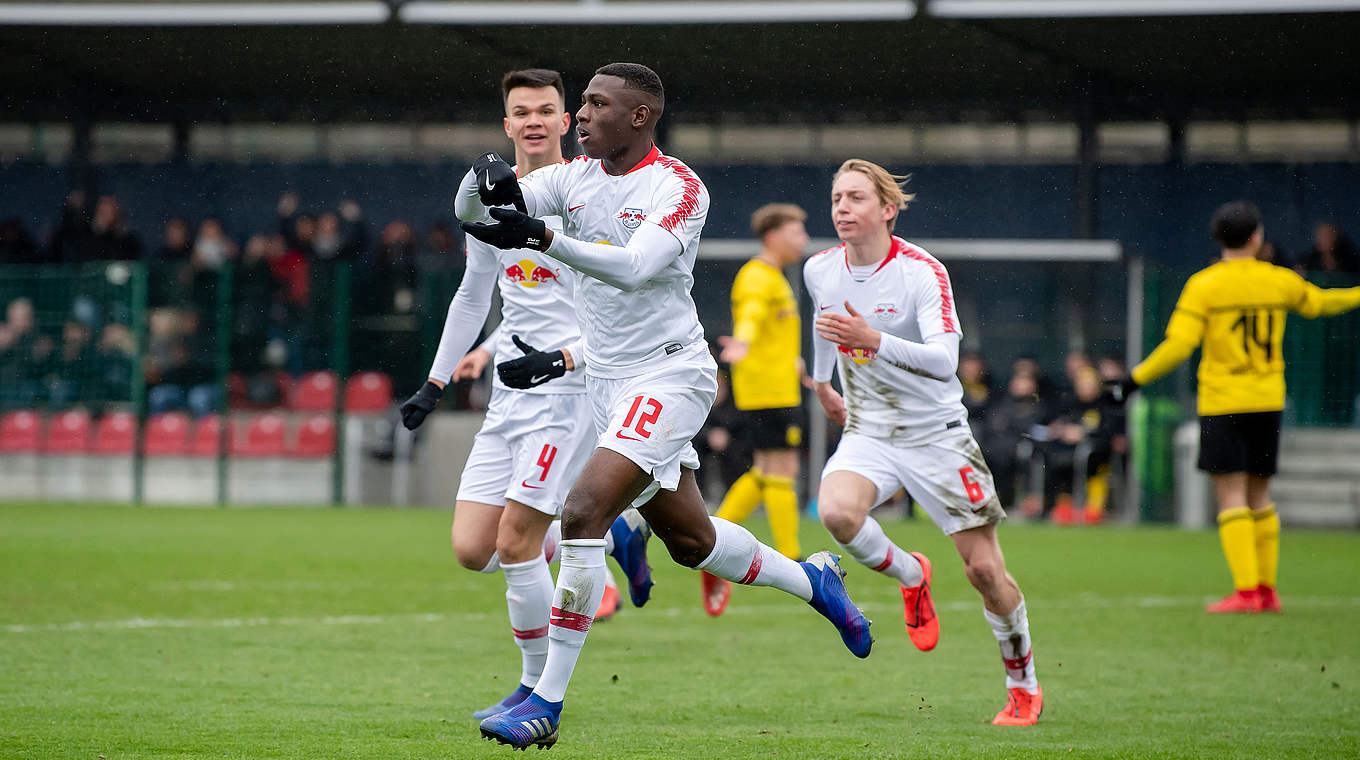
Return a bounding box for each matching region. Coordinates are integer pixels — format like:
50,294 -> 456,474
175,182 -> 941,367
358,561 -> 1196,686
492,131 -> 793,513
401,69 -> 651,719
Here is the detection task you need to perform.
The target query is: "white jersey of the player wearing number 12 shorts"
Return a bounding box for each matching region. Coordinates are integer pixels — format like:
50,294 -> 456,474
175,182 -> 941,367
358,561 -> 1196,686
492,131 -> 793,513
460,145 -> 709,378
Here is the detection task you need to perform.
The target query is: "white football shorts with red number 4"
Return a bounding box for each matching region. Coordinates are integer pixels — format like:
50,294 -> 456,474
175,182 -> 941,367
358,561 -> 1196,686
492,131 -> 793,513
458,389 -> 596,515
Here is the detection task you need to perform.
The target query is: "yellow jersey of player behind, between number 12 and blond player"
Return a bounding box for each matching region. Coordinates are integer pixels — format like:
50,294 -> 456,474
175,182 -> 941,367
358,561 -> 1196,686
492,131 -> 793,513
732,258 -> 802,409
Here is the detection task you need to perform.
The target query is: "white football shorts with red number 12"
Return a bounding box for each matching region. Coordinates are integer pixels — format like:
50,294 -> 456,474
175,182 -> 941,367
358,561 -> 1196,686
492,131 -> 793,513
586,344 -> 718,506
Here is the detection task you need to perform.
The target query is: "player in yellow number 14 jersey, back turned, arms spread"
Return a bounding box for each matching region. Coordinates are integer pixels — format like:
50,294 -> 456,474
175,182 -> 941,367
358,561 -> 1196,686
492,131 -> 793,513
1111,201 -> 1360,612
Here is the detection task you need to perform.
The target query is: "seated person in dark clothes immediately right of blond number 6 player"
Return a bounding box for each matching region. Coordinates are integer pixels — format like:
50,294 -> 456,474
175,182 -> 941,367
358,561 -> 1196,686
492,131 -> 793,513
987,364 -> 1051,517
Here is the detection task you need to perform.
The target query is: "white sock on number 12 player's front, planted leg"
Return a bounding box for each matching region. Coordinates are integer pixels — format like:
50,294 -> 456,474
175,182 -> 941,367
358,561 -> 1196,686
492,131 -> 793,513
533,538 -> 605,702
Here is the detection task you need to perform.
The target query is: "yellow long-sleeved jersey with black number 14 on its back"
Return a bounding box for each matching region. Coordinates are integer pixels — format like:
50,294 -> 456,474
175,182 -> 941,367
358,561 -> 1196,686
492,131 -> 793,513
1133,258 -> 1360,416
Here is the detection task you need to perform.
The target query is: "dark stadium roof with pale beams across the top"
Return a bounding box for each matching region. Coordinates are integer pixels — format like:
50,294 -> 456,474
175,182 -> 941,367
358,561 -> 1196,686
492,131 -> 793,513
0,0 -> 1360,122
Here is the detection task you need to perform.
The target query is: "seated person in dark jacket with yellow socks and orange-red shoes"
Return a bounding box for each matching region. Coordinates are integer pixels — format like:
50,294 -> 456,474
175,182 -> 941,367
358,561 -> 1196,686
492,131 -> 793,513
1044,366 -> 1123,525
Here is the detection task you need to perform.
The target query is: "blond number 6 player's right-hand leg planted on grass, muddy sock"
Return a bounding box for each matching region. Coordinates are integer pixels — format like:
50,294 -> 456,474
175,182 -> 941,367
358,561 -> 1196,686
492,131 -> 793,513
951,523 -> 1043,726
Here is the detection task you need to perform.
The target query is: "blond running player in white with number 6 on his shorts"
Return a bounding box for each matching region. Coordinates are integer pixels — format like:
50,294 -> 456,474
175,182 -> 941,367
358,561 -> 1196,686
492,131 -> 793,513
804,159 -> 1043,726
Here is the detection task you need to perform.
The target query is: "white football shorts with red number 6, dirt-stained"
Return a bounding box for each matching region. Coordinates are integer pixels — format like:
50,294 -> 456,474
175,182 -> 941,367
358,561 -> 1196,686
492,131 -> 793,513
821,426 -> 1006,536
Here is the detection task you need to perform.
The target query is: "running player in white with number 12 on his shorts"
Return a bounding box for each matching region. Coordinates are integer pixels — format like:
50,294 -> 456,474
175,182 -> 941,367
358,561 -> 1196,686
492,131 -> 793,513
457,64 -> 872,748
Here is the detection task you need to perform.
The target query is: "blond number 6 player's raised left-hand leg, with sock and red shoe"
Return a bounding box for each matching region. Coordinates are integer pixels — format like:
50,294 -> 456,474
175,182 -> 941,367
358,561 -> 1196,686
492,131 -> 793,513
817,470 -> 940,651
